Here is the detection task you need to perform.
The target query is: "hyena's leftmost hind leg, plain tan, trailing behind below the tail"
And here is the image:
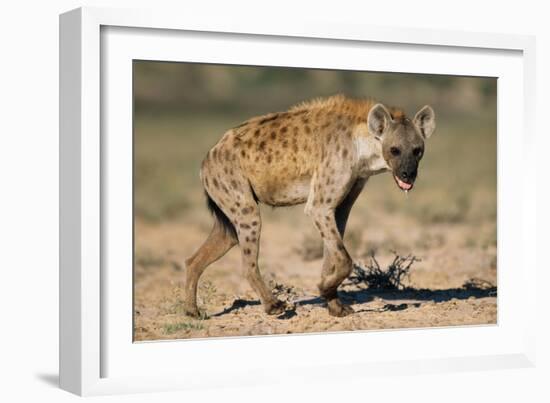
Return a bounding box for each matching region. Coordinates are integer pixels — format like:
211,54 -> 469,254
184,221 -> 237,317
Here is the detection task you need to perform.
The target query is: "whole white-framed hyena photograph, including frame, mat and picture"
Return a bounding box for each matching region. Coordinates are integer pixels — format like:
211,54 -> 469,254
60,8 -> 536,395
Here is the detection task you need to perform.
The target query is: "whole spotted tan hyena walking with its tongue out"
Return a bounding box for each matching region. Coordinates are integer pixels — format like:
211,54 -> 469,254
185,96 -> 435,316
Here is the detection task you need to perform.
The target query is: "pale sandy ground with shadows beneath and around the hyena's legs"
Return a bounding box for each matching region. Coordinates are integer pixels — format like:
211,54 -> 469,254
134,213 -> 497,341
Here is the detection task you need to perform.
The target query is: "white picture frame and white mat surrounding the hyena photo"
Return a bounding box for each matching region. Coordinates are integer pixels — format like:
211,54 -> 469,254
60,8 -> 536,395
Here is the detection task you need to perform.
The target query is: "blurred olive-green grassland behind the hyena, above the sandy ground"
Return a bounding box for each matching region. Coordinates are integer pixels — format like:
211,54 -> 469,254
134,61 -> 496,221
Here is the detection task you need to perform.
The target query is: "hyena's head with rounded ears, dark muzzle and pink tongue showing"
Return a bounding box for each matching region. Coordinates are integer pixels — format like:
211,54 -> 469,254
367,104 -> 435,191
